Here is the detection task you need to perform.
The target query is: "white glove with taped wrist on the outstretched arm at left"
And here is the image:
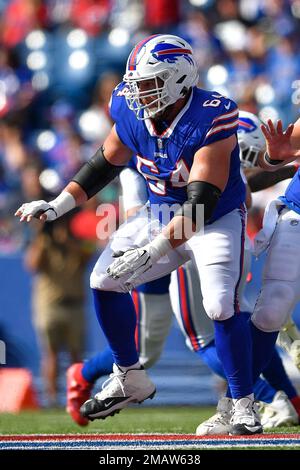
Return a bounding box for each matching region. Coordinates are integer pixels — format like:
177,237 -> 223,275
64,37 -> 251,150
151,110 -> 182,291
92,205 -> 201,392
15,191 -> 76,222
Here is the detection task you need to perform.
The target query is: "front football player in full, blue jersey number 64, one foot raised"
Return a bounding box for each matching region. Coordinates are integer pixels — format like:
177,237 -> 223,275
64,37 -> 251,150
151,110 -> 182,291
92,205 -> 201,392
17,35 -> 262,434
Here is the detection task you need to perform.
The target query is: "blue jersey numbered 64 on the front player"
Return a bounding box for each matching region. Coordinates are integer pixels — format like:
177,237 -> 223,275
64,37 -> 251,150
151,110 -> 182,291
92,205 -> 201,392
110,82 -> 245,222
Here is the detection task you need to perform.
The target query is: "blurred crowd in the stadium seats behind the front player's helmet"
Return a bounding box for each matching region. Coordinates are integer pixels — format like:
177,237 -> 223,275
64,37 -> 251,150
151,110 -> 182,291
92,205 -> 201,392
0,0 -> 300,253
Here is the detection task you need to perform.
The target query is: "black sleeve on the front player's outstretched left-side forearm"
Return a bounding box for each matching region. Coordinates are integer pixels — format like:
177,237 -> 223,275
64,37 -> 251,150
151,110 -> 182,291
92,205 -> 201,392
72,147 -> 124,199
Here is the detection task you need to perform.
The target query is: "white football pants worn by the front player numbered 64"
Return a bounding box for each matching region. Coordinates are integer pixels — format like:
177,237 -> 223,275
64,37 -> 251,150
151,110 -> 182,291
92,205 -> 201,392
90,205 -> 245,320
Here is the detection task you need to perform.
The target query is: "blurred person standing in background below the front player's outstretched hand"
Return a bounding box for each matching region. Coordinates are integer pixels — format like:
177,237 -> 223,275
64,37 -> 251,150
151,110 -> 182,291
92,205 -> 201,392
25,211 -> 91,405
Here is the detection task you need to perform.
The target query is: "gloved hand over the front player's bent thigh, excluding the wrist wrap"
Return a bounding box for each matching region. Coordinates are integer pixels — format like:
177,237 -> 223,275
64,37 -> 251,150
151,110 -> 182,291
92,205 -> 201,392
106,248 -> 152,280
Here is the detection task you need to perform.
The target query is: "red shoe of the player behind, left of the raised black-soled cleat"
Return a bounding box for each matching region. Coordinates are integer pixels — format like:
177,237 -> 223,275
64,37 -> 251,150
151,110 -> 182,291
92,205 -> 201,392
66,362 -> 94,426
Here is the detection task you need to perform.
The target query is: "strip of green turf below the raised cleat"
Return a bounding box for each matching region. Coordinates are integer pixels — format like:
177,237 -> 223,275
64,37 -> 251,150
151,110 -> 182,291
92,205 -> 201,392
0,406 -> 300,434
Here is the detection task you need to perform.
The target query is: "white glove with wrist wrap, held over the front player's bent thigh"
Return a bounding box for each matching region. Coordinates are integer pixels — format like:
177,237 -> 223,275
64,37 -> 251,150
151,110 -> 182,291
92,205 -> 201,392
106,235 -> 172,282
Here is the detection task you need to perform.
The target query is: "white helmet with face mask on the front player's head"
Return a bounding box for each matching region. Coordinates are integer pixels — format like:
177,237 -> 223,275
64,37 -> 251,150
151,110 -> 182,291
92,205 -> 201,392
124,34 -> 198,120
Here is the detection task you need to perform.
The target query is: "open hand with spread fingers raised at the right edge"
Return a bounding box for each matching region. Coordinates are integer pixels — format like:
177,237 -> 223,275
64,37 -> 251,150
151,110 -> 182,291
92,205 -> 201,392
261,119 -> 300,160
